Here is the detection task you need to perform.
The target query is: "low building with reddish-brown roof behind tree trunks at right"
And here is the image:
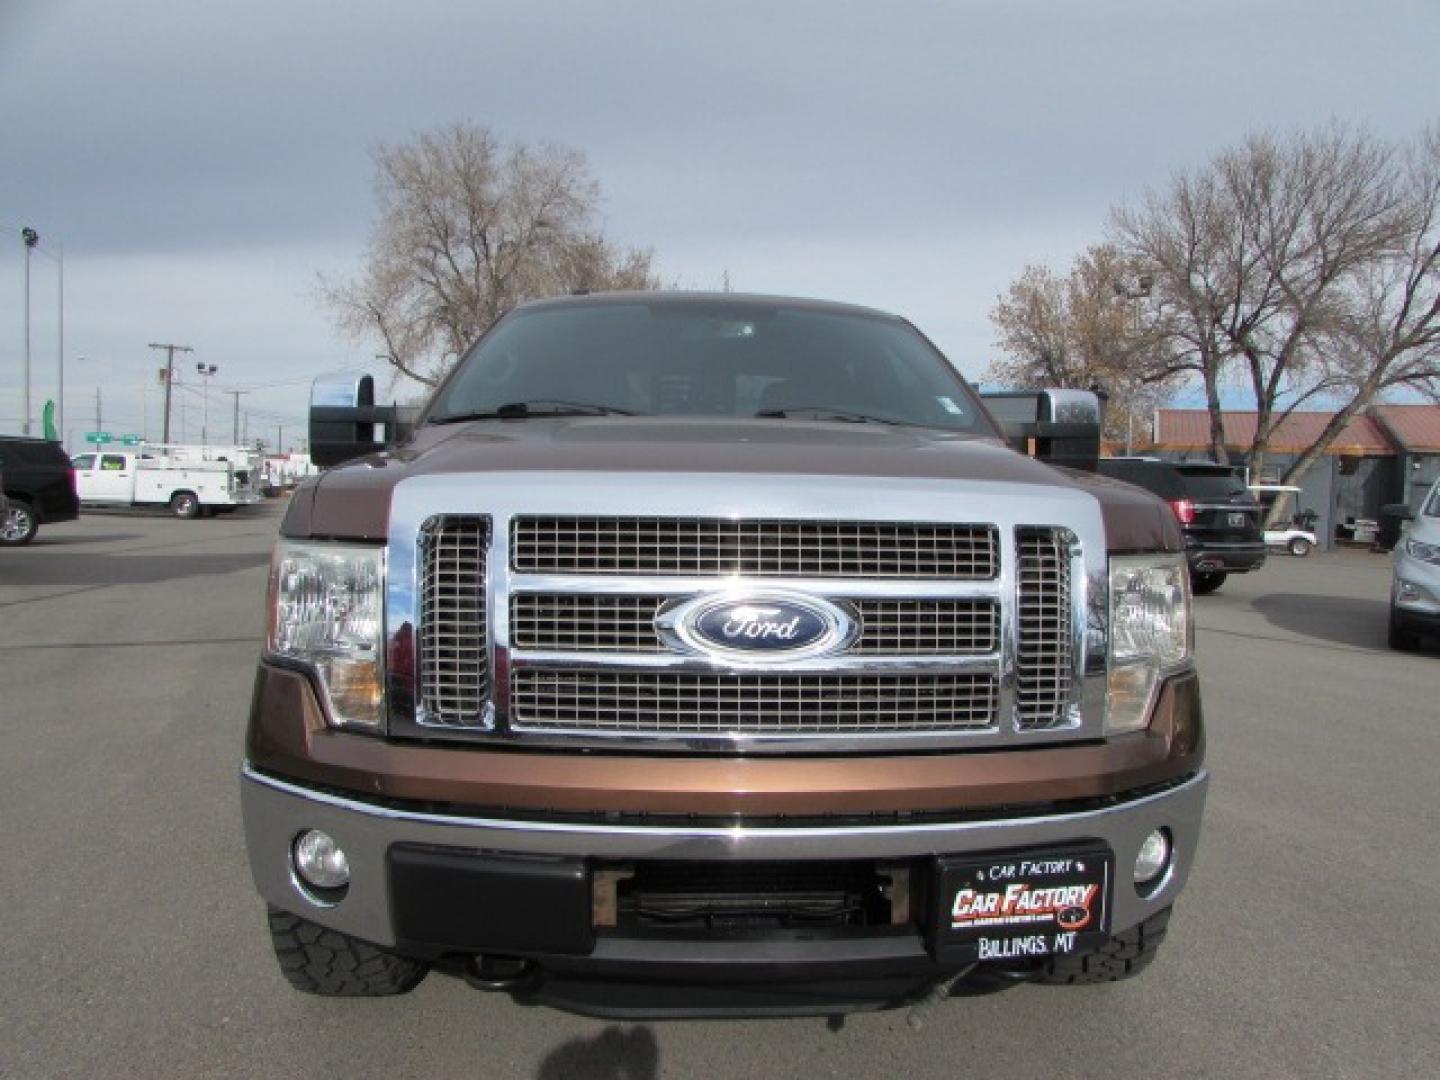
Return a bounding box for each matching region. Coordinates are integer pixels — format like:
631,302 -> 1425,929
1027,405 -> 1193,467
1146,405 -> 1440,546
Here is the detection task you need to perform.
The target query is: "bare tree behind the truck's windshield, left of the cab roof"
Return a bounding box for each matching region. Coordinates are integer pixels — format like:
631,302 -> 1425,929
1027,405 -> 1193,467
321,122 -> 658,386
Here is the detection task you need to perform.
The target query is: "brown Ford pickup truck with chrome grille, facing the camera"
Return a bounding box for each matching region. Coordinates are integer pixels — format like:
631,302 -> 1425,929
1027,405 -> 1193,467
242,294 -> 1207,1015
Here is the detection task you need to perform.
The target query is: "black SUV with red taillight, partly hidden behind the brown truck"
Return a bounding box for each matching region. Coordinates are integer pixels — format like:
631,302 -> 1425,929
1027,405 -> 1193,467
1100,458 -> 1264,593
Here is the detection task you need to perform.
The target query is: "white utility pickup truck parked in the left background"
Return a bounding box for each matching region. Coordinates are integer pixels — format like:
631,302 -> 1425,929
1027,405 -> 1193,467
72,451 -> 256,517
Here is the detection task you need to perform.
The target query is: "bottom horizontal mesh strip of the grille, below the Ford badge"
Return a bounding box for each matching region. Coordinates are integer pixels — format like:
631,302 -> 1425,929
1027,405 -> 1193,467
510,668 -> 998,736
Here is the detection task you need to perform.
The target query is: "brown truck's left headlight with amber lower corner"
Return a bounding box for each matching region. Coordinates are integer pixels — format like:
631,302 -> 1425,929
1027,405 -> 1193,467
265,540 -> 384,732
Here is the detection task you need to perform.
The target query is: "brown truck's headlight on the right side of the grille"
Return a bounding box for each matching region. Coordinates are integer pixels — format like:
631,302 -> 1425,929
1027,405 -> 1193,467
1104,554 -> 1192,734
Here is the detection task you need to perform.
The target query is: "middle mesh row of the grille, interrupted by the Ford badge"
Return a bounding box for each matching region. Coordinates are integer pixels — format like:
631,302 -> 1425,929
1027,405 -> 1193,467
510,593 -> 999,657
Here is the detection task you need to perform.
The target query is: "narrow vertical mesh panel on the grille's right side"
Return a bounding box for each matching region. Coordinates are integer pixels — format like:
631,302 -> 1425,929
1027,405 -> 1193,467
1015,528 -> 1074,730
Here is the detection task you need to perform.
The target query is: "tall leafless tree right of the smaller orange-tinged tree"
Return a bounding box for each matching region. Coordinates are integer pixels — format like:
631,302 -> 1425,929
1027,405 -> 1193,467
1112,125 -> 1404,471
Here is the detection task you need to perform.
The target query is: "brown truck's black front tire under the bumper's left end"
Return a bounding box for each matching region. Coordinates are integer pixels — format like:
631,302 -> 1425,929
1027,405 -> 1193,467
269,907 -> 431,998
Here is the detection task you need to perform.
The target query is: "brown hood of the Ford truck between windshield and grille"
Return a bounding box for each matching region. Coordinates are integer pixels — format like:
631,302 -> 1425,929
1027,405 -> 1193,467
281,416 -> 1181,552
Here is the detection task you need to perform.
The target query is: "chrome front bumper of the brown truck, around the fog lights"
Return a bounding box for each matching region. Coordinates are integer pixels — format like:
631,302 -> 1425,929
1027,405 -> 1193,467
240,766 -> 1210,945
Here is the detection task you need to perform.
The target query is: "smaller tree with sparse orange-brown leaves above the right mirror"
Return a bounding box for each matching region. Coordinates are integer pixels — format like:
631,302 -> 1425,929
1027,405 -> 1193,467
985,245 -> 1174,445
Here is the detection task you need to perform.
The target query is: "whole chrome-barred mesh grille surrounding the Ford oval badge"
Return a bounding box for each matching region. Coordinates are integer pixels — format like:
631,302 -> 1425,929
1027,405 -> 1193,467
413,513 -> 1082,752
